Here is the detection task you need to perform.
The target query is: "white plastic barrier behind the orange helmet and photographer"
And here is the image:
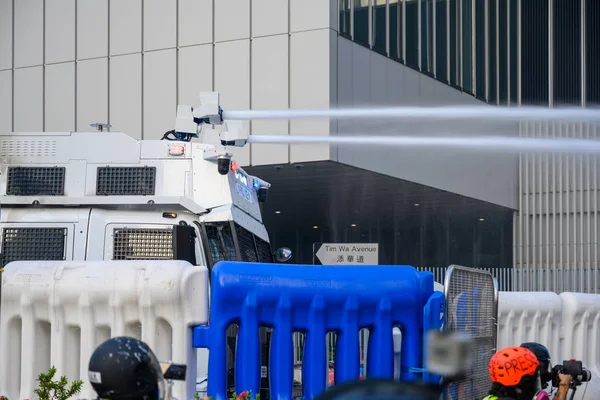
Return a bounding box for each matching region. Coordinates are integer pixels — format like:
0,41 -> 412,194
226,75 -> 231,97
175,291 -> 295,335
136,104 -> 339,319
498,292 -> 600,400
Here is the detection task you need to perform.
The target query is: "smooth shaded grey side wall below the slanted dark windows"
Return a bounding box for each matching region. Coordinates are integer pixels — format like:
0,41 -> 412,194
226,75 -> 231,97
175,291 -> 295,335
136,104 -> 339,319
331,36 -> 519,208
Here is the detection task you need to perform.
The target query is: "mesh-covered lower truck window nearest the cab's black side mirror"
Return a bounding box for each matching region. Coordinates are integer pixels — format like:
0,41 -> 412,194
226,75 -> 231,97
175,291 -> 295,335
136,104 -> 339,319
113,228 -> 173,260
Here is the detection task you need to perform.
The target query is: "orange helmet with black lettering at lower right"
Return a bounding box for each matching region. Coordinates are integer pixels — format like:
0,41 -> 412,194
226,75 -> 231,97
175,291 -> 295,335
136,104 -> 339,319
490,347 -> 540,386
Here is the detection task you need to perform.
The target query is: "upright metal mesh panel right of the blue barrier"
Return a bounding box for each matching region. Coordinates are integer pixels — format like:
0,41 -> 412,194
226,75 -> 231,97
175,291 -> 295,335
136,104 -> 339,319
444,266 -> 498,400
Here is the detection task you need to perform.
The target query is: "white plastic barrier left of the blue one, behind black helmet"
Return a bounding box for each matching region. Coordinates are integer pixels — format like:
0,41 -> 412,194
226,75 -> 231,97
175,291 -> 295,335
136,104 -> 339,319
0,261 -> 208,400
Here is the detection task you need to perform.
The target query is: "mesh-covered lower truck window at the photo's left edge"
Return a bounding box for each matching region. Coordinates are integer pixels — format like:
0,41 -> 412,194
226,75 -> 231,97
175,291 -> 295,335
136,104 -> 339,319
1,228 -> 67,267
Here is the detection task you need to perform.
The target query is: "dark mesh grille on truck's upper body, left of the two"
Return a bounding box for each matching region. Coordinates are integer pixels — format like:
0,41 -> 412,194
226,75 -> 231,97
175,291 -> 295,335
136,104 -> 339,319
6,167 -> 65,196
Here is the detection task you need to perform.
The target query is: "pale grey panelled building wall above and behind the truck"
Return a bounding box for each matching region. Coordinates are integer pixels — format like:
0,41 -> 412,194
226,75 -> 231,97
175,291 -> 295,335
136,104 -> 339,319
0,0 -> 336,165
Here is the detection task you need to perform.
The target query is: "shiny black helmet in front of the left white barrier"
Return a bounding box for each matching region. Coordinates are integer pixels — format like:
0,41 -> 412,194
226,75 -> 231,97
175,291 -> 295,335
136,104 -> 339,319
88,336 -> 165,400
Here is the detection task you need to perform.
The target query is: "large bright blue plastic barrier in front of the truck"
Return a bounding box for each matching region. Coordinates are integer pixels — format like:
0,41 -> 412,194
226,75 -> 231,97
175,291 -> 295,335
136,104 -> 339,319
193,262 -> 440,400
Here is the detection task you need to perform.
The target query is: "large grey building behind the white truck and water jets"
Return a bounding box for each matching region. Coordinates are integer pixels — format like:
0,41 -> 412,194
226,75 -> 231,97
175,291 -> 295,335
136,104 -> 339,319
0,0 -> 600,292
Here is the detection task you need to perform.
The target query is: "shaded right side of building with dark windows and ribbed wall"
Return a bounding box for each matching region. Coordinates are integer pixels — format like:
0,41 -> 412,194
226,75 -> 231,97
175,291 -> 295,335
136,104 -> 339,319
250,0 -> 600,292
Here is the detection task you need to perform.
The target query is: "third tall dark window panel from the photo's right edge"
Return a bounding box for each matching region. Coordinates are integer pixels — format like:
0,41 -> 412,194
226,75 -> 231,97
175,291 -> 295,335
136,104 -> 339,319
521,0 -> 548,106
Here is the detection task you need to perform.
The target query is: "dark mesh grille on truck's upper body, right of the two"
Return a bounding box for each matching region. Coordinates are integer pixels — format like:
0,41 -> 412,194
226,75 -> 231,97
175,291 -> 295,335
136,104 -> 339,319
96,167 -> 156,196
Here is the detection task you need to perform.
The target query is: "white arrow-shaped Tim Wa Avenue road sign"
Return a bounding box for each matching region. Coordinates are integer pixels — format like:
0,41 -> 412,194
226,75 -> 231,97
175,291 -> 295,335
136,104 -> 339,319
313,243 -> 379,265
